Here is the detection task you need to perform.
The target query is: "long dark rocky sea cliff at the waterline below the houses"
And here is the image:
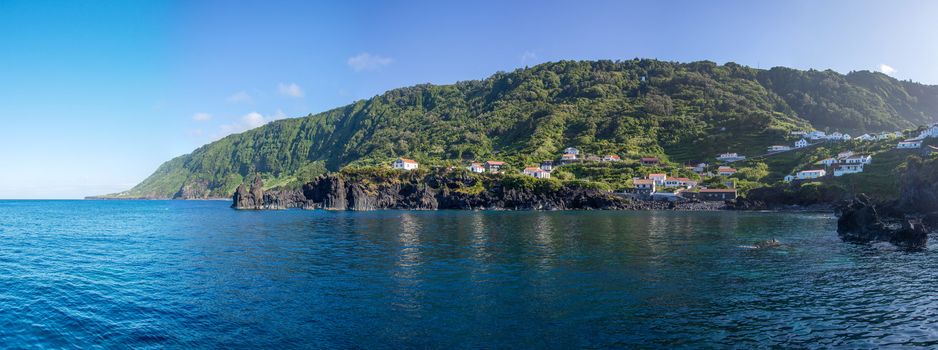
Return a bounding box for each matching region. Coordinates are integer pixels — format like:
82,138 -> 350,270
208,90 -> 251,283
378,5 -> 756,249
232,173 -> 692,211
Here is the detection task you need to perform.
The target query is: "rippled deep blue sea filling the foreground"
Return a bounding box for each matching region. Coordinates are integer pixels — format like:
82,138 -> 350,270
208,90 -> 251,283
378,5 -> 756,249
0,201 -> 938,349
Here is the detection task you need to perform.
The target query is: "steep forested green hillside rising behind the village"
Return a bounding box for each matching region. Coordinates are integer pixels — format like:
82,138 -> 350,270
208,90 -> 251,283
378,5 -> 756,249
104,59 -> 938,198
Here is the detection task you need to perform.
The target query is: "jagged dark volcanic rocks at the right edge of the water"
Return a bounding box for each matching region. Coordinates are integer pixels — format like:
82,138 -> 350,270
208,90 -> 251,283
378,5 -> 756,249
837,157 -> 938,249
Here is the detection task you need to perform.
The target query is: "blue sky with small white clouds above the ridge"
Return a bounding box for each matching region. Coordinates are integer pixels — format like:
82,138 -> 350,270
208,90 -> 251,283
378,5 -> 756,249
0,0 -> 938,198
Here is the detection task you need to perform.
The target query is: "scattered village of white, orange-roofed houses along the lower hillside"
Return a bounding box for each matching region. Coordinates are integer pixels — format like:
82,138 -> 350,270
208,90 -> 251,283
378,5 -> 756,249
391,123 -> 938,201
